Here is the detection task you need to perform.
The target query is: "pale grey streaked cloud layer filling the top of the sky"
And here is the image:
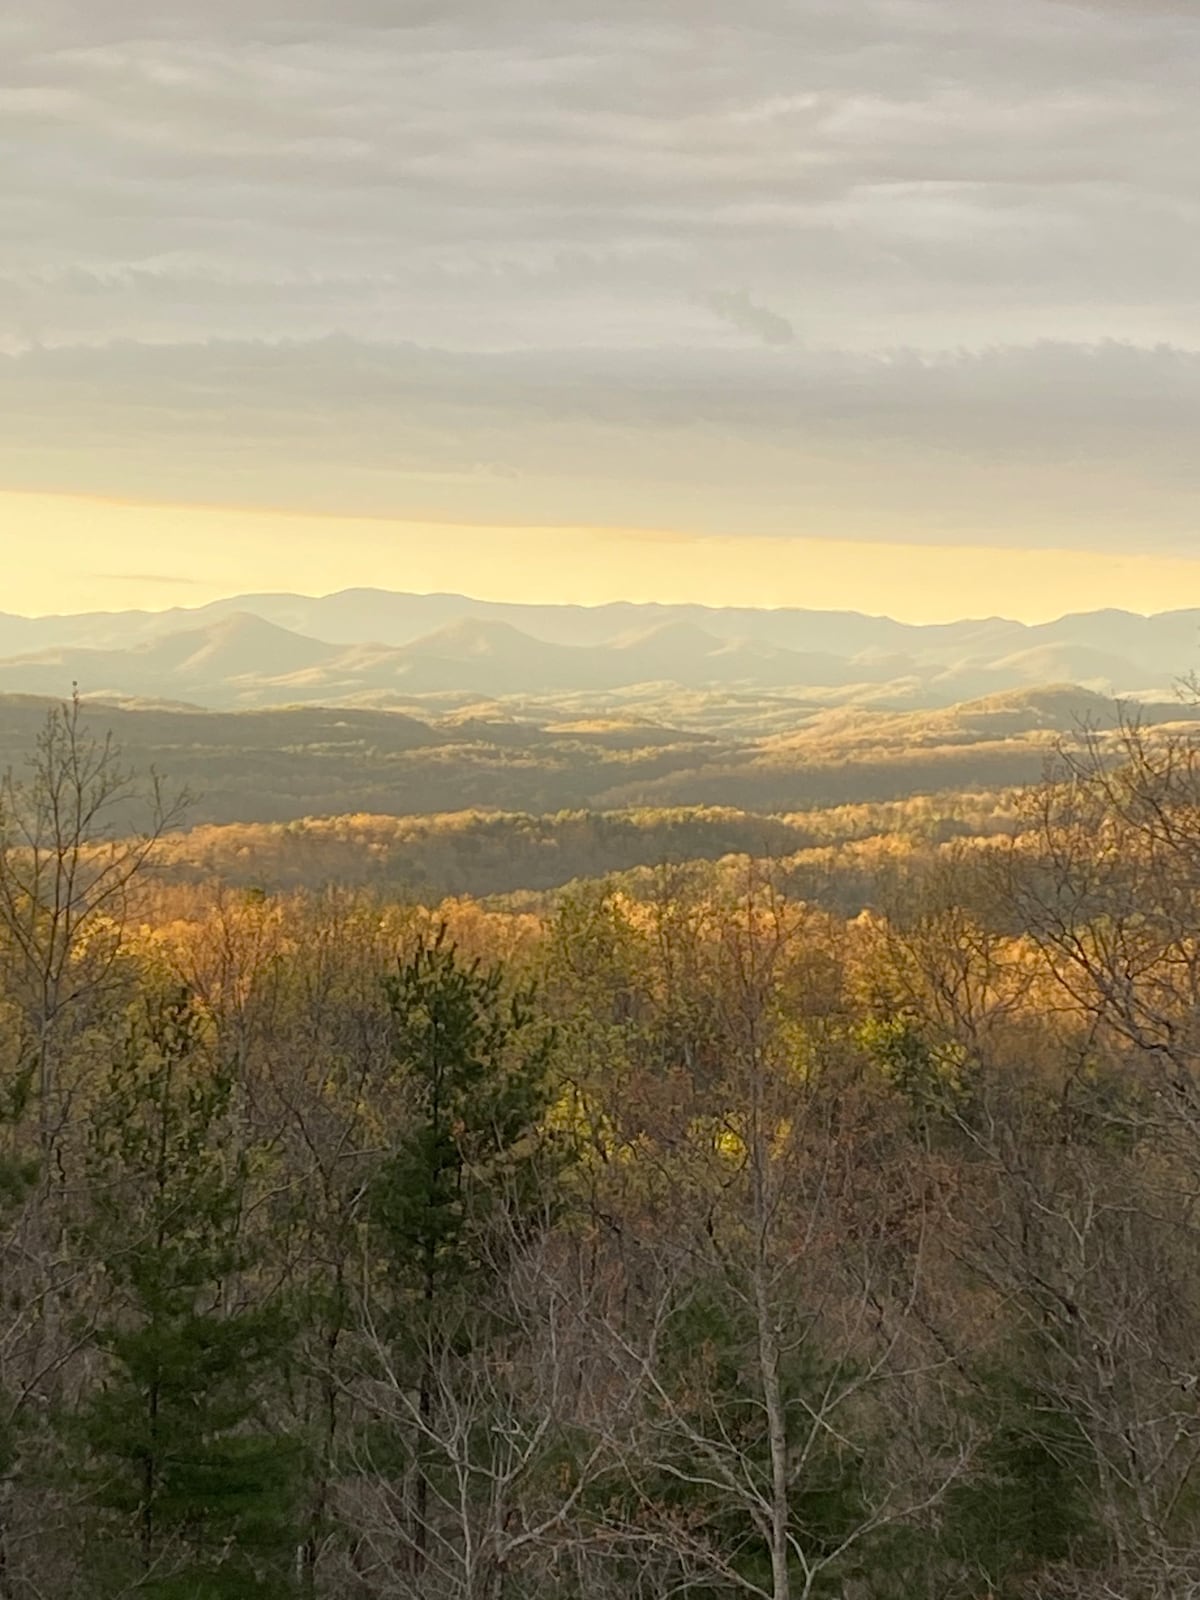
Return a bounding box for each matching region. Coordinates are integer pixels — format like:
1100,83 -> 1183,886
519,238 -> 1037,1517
9,0 -> 1200,347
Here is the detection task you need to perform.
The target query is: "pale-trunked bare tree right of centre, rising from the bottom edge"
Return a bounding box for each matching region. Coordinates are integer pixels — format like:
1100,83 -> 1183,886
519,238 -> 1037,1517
556,874 -> 965,1600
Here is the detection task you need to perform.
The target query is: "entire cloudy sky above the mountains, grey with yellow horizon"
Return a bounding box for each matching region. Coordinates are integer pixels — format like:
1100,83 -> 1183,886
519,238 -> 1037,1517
0,0 -> 1200,621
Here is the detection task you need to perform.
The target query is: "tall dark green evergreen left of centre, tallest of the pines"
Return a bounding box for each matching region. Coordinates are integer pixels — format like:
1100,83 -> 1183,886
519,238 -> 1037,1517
361,926 -> 562,1595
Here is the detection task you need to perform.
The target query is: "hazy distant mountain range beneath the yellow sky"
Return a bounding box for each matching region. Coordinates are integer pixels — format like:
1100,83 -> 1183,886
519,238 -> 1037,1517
0,589 -> 1200,709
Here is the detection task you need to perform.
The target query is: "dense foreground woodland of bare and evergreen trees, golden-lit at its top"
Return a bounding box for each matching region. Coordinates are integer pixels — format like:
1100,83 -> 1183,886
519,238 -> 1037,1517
0,706 -> 1200,1600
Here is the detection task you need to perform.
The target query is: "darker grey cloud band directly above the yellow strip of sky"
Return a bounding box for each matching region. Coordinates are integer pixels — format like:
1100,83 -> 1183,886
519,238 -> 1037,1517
0,336 -> 1200,554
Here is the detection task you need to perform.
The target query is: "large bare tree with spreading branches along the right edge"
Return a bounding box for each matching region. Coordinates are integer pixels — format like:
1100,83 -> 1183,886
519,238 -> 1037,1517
893,715 -> 1200,1600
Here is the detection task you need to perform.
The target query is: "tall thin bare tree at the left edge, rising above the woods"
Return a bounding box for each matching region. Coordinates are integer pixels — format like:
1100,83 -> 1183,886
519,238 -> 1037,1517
0,698 -> 184,1595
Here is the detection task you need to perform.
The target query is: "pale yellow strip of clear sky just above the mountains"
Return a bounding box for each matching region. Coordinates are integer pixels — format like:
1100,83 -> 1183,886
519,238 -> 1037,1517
0,493 -> 1200,622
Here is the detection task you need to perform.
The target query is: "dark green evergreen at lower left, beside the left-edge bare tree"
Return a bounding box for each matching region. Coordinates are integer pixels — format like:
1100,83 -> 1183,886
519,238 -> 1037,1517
77,994 -> 298,1600
